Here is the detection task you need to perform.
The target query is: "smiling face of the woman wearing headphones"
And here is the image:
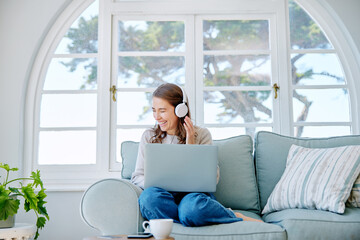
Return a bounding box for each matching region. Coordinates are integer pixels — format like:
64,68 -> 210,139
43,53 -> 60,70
152,97 -> 179,135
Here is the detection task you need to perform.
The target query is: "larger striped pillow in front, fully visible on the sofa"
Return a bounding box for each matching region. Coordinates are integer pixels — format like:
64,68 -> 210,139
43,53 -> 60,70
262,145 -> 360,214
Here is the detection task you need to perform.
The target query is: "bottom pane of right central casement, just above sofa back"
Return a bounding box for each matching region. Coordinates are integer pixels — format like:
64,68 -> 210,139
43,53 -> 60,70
208,127 -> 272,141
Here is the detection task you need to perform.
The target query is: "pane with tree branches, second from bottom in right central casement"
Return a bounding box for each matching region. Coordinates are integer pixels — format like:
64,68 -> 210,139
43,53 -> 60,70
204,91 -> 272,124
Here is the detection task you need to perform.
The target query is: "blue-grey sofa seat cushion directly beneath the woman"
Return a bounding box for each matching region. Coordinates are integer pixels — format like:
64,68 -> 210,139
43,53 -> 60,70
171,211 -> 286,240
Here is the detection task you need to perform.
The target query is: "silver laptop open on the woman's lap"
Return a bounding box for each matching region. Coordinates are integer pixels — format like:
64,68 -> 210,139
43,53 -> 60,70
144,143 -> 218,192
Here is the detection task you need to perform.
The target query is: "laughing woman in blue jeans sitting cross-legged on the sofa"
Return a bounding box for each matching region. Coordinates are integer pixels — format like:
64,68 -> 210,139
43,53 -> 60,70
131,83 -> 261,226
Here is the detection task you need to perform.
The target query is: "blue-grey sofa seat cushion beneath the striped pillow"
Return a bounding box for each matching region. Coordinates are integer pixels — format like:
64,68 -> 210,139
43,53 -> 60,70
263,208 -> 360,240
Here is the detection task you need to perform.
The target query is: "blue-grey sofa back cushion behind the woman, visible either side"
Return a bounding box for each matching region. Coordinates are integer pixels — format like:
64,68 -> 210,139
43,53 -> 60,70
121,135 -> 260,213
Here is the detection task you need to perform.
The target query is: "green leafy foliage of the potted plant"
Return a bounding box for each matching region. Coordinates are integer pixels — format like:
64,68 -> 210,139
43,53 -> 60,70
0,163 -> 49,239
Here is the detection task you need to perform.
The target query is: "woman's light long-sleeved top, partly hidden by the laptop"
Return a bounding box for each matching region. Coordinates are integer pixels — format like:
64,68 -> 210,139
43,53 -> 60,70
131,126 -> 214,188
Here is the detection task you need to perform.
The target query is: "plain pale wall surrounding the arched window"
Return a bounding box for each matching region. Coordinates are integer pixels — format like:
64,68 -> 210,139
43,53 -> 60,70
0,0 -> 360,240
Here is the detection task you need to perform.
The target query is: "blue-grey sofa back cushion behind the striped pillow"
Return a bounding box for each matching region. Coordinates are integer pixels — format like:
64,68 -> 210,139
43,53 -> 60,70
255,131 -> 360,209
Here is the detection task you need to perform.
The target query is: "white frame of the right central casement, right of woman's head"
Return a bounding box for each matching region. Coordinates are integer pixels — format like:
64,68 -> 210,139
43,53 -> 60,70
195,13 -> 283,136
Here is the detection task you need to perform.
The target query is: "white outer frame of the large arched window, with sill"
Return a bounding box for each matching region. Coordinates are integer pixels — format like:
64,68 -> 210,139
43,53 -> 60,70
23,0 -> 360,191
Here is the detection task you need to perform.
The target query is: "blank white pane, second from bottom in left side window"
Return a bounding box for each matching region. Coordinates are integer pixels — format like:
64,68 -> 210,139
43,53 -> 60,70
40,94 -> 97,127
